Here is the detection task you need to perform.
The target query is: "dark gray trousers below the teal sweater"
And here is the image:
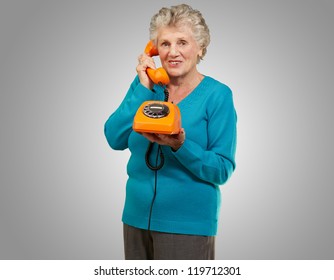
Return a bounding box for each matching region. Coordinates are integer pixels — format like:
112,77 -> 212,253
123,224 -> 215,260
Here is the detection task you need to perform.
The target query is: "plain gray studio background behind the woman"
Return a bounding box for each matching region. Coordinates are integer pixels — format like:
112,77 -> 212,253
0,0 -> 334,259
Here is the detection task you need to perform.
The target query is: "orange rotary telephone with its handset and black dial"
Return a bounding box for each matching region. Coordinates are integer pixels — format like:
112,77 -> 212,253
133,41 -> 181,134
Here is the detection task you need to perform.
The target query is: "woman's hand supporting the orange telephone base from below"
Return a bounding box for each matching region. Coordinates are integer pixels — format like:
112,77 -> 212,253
141,128 -> 186,152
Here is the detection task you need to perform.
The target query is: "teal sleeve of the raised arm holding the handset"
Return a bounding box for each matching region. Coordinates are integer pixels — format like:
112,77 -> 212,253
104,76 -> 153,150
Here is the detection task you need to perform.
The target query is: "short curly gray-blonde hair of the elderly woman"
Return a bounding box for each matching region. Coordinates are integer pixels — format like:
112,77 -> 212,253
149,4 -> 210,62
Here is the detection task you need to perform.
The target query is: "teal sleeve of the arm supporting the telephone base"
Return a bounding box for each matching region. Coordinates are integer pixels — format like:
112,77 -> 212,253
174,85 -> 237,185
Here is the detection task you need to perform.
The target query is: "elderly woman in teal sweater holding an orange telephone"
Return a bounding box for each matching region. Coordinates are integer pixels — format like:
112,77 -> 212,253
105,4 -> 236,260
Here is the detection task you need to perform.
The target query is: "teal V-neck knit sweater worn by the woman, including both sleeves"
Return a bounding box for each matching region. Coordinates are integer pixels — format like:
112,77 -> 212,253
104,76 -> 237,236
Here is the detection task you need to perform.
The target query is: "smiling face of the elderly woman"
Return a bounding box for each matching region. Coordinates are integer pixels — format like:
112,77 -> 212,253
157,25 -> 202,77
